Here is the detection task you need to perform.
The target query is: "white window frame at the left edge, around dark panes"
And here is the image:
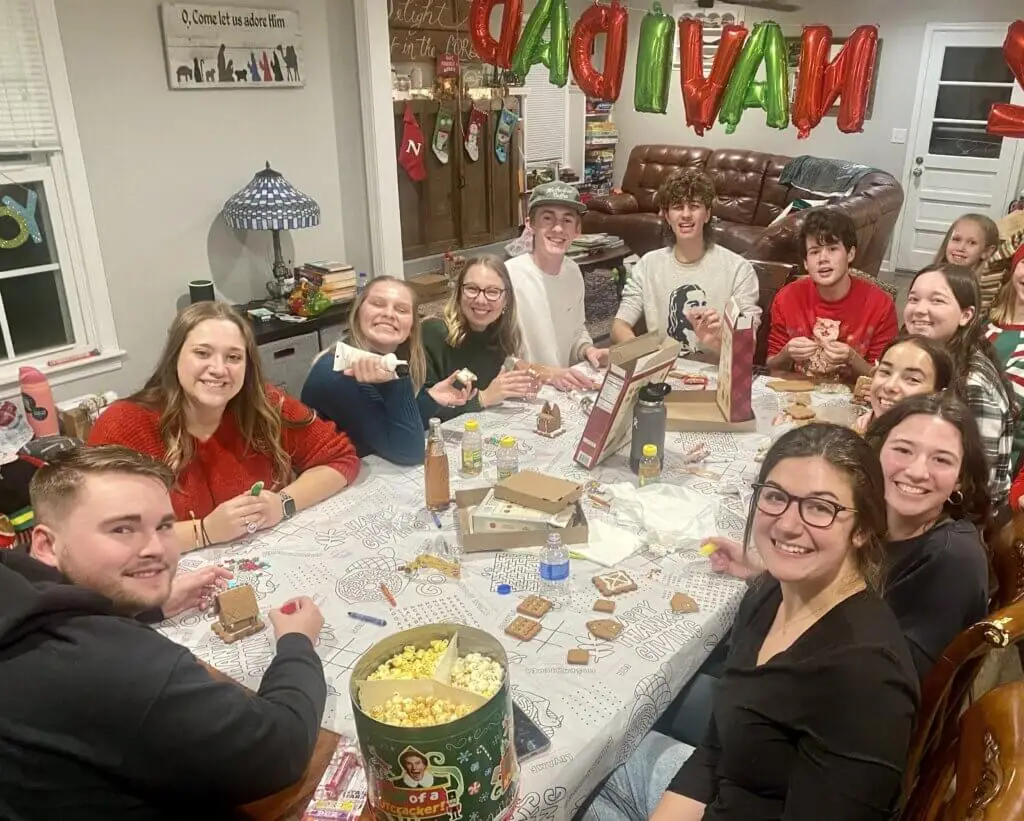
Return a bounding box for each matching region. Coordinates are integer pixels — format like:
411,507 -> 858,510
0,0 -> 125,398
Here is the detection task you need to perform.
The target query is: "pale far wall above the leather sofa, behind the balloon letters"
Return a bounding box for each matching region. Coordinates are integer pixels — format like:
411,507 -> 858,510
615,0 -> 1022,180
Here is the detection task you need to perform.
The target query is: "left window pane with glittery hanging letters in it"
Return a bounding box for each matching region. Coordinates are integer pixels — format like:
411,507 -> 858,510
0,177 -> 57,271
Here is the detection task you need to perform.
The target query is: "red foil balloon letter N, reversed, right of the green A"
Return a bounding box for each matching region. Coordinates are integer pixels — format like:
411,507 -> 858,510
793,26 -> 879,139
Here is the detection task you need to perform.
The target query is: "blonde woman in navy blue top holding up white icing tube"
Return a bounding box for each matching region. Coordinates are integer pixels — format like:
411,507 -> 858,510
301,276 -> 472,465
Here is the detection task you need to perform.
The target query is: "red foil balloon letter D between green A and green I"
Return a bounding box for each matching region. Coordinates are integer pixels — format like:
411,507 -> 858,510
569,0 -> 629,102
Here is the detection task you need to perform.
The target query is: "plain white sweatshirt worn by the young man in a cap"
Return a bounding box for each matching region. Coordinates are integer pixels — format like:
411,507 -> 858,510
505,254 -> 594,368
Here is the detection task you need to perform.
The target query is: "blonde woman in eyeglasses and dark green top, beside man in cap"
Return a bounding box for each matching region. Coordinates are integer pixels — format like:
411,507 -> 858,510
420,254 -> 543,420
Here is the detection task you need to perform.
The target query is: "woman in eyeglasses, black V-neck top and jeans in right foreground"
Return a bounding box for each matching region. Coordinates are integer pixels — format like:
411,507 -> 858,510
584,424 -> 919,821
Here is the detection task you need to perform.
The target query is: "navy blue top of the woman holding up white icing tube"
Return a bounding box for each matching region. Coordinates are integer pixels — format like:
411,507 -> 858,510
301,355 -> 424,465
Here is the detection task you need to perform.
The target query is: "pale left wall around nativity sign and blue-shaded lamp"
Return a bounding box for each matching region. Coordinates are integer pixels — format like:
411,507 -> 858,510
56,0 -> 368,398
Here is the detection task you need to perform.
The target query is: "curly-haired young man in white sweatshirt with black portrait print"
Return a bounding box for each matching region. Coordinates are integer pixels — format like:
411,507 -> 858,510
611,168 -> 761,355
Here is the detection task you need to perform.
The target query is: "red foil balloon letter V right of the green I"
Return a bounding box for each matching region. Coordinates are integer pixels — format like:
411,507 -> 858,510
679,17 -> 746,136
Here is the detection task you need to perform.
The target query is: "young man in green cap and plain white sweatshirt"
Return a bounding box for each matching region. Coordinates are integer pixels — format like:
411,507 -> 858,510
506,182 -> 608,390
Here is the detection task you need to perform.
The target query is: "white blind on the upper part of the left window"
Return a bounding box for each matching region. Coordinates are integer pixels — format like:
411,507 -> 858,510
0,0 -> 60,152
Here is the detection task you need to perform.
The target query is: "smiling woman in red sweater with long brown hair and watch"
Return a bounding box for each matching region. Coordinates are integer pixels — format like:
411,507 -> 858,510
89,302 -> 359,550
